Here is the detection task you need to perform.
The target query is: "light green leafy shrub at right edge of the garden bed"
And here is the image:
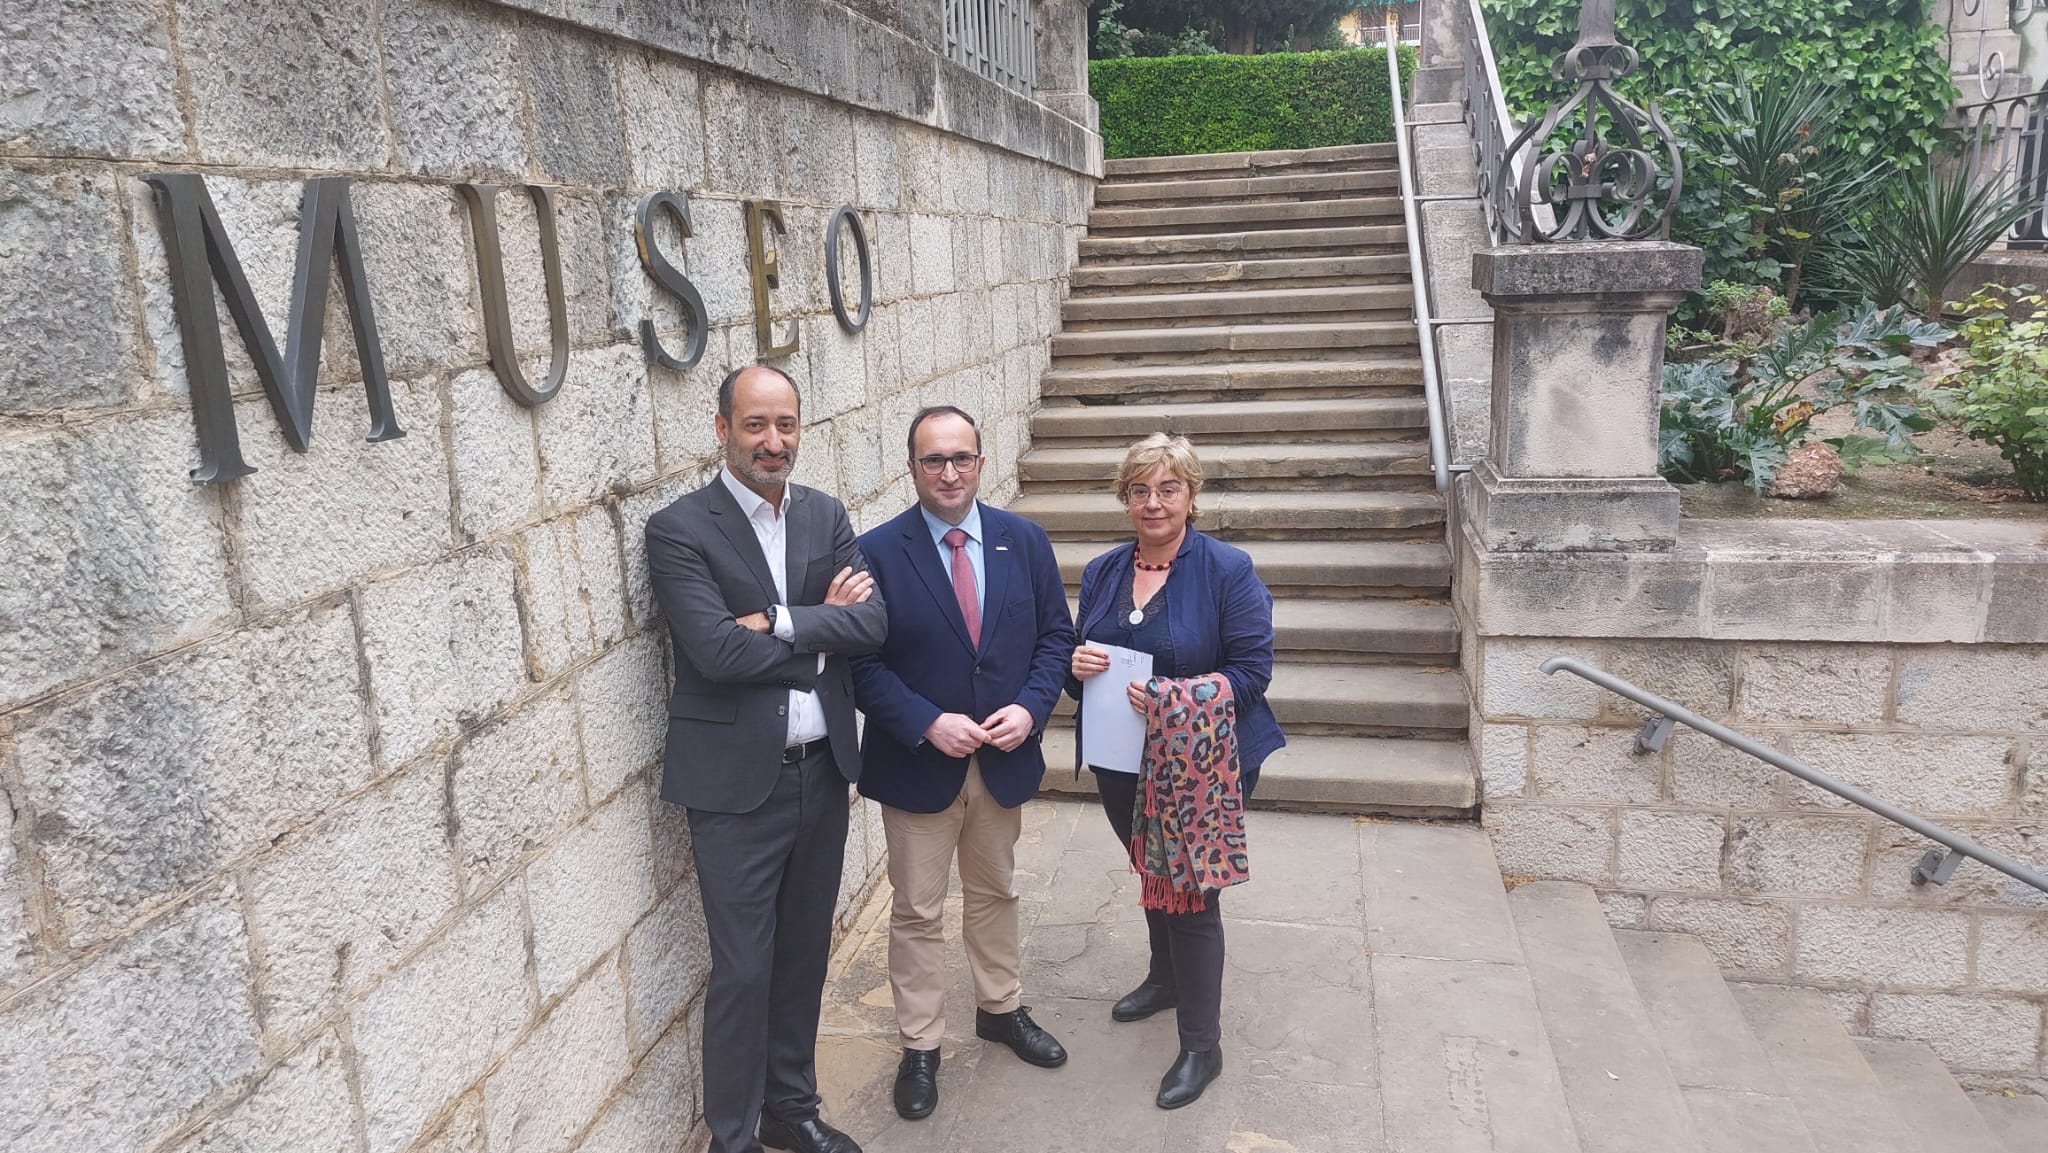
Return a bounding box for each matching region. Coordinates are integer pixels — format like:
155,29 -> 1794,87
1942,285 -> 2048,500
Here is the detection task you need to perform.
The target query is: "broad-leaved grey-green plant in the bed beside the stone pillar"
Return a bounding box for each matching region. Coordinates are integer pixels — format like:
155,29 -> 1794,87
1657,305 -> 1950,494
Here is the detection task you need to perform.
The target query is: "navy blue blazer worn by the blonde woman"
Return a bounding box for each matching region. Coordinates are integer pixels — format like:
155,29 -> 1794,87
1073,526 -> 1286,797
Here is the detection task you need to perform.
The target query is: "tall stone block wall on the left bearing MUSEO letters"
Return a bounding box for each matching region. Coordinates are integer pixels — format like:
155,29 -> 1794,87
0,0 -> 1100,1153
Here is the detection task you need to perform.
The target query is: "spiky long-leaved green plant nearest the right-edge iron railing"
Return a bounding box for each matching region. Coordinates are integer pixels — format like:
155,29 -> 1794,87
1833,164 -> 2032,315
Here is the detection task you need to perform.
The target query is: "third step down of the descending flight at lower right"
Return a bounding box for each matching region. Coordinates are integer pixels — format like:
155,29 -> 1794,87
1733,985 -> 1923,1153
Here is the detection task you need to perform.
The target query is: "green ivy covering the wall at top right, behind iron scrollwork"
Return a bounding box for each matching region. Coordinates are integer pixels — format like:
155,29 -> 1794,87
1481,0 -> 1956,166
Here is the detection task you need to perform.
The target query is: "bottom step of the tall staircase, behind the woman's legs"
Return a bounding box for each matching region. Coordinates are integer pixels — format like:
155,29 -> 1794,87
1044,725 -> 1479,817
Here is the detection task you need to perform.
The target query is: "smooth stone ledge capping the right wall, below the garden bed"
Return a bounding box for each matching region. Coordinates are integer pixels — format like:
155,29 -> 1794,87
1456,505 -> 2048,643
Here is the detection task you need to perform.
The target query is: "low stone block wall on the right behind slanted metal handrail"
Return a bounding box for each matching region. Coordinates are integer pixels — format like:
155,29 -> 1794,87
1466,637 -> 2048,1079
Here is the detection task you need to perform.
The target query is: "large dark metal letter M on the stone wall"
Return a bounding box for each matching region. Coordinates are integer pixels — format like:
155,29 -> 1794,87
143,172 -> 406,485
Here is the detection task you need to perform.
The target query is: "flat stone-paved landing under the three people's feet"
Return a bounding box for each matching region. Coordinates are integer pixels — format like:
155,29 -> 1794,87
802,799 -> 1571,1153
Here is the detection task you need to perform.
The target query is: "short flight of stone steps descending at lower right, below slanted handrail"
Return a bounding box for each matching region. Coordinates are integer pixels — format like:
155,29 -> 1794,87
1425,881 -> 2048,1153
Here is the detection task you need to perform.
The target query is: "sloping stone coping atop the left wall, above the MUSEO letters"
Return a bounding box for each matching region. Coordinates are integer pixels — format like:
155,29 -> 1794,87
473,0 -> 1102,178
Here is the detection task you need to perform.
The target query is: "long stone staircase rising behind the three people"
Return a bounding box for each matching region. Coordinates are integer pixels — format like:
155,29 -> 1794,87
1012,143 -> 1477,815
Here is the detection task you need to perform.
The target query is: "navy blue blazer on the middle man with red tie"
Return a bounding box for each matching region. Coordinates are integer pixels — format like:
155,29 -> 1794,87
852,504 -> 1073,813
